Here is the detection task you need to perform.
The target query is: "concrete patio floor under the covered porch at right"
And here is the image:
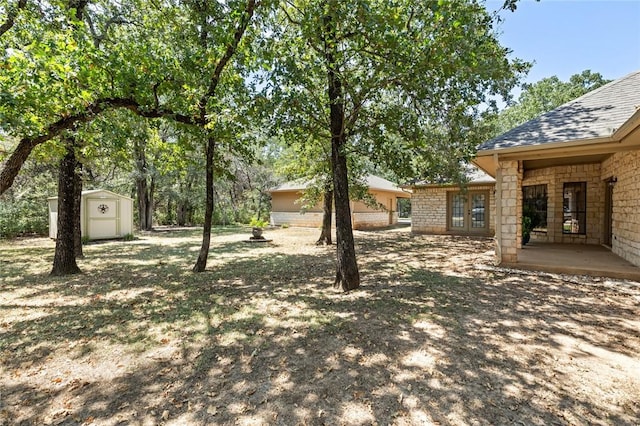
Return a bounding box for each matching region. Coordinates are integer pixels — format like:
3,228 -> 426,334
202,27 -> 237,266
502,242 -> 640,282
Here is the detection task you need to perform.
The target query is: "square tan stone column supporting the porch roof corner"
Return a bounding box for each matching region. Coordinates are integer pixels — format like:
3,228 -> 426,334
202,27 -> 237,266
496,160 -> 522,263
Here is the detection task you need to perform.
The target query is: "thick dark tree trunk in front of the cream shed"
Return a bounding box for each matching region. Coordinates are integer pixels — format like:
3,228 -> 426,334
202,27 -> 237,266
51,144 -> 80,276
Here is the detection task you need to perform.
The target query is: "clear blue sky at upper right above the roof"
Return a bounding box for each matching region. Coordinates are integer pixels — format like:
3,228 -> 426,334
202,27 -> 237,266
486,0 -> 640,82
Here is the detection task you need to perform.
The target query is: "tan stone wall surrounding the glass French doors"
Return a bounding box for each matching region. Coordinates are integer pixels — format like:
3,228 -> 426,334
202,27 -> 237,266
411,184 -> 496,235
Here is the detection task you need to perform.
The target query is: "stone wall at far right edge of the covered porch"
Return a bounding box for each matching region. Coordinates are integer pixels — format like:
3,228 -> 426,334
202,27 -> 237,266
601,151 -> 640,267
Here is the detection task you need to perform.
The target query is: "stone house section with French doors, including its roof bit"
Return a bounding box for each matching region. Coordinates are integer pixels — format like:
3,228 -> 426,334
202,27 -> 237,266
411,168 -> 495,236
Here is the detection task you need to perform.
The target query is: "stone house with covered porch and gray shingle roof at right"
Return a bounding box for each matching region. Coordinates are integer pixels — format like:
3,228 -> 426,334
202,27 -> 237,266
472,71 -> 640,266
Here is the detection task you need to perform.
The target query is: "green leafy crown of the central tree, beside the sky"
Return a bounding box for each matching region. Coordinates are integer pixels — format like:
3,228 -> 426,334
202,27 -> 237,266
268,0 -> 529,186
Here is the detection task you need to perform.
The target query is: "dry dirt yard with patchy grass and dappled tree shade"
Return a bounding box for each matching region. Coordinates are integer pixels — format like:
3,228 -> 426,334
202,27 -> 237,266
0,228 -> 640,425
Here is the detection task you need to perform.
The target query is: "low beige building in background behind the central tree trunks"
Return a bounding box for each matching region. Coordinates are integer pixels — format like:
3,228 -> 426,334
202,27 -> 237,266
269,175 -> 411,229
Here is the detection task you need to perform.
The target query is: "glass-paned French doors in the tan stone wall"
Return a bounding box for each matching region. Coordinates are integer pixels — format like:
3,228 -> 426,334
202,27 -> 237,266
447,191 -> 489,234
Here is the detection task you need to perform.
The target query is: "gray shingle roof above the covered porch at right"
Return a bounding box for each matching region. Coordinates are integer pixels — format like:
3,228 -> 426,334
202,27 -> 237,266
478,71 -> 640,151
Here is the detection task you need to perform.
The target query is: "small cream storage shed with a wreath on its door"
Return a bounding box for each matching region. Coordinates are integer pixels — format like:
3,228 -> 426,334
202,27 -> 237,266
47,189 -> 133,240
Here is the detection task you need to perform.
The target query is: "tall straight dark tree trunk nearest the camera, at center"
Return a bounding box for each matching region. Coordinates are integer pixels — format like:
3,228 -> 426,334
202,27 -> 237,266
323,10 -> 360,291
